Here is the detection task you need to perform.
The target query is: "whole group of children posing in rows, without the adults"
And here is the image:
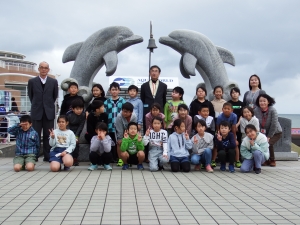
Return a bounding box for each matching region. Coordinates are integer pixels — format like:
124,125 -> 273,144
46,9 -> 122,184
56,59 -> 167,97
8,82 -> 269,174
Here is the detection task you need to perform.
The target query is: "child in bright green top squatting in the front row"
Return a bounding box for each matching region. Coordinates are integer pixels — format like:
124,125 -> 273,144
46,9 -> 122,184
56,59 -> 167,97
121,122 -> 145,170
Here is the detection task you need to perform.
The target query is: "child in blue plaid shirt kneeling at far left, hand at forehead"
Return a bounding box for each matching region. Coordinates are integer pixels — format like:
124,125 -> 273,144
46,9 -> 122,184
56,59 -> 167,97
8,115 -> 40,172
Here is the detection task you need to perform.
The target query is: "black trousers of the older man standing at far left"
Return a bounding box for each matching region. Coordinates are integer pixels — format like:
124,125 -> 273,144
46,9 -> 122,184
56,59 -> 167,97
32,111 -> 54,160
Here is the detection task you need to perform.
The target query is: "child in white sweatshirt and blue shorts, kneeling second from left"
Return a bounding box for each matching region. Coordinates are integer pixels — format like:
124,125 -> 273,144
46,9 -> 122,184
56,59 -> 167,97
49,115 -> 76,172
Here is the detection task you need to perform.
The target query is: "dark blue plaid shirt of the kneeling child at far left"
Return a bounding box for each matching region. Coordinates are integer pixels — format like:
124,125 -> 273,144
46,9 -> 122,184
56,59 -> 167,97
8,124 -> 40,155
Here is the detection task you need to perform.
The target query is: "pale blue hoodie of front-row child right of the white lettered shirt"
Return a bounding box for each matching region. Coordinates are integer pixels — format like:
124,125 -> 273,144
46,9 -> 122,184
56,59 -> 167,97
168,132 -> 193,157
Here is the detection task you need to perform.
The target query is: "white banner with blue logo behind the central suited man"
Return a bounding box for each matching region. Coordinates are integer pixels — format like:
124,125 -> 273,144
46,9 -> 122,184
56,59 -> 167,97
109,76 -> 178,89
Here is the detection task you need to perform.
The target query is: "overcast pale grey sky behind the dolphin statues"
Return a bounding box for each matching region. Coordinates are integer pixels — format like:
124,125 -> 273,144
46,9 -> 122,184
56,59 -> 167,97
0,0 -> 300,114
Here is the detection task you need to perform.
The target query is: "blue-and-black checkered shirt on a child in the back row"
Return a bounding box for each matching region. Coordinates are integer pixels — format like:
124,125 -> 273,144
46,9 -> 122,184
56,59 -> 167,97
104,97 -> 126,132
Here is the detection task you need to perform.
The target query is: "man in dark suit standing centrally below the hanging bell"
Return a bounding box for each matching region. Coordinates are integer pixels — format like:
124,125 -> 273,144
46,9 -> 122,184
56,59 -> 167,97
141,66 -> 167,117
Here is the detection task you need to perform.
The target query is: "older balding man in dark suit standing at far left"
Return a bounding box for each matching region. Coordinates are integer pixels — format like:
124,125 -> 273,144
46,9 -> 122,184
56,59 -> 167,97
28,62 -> 58,161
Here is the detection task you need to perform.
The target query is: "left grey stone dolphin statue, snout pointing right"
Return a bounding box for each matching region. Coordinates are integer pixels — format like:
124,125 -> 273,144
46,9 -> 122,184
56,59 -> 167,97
61,26 -> 143,101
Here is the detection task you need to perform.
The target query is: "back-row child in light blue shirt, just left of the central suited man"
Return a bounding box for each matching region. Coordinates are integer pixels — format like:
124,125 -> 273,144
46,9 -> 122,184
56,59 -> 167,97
127,85 -> 144,130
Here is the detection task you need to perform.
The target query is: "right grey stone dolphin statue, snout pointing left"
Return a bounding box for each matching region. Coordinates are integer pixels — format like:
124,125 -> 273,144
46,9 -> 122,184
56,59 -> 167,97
159,30 -> 237,100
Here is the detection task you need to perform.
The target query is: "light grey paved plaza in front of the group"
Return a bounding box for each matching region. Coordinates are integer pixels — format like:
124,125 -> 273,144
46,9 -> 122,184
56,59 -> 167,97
0,158 -> 300,225
